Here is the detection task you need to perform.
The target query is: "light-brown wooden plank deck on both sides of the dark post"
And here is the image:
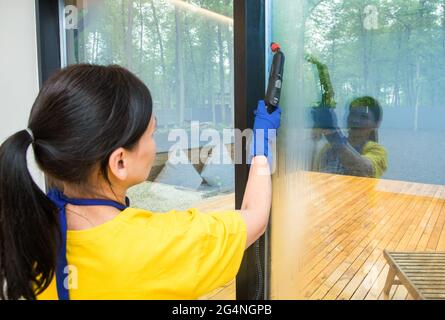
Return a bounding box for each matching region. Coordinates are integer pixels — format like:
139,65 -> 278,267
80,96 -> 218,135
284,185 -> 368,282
194,173 -> 445,300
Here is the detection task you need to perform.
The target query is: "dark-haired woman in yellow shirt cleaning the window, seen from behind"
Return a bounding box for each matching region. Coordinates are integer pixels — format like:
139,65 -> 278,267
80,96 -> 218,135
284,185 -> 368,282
0,65 -> 280,299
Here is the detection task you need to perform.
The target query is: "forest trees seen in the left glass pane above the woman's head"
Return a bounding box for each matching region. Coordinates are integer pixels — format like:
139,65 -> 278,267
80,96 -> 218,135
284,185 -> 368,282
65,0 -> 234,128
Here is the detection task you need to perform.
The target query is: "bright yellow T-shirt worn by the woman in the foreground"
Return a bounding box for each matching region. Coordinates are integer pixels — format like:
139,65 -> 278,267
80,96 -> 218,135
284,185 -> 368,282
38,208 -> 247,300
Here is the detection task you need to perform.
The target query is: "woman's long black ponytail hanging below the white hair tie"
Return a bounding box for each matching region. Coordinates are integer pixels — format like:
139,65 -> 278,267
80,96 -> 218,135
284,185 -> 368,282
0,130 -> 60,299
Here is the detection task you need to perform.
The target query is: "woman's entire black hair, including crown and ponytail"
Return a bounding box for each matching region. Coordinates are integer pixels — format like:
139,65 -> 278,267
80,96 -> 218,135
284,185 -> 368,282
0,64 -> 152,299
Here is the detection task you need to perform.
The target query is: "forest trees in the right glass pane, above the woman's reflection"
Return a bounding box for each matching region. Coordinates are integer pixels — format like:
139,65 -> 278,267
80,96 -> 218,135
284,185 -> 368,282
303,0 -> 445,129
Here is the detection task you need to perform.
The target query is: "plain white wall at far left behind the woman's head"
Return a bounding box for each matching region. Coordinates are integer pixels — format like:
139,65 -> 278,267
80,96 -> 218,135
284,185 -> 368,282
0,0 -> 43,188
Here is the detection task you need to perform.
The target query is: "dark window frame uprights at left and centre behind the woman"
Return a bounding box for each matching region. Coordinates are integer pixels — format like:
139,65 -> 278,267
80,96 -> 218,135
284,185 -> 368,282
35,0 -> 269,300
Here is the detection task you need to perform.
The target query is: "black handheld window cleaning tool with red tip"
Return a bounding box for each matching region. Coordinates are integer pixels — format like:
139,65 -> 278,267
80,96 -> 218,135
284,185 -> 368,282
264,42 -> 286,113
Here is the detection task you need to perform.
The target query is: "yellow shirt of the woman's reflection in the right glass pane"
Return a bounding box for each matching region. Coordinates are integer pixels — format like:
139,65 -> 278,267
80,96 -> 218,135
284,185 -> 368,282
314,141 -> 388,179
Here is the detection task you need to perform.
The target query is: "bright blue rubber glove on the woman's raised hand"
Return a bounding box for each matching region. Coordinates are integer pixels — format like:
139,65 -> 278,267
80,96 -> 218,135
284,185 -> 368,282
249,100 -> 281,165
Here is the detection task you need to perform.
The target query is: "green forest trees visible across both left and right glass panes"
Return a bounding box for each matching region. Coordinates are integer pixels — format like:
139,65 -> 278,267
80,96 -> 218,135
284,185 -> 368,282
65,0 -> 445,130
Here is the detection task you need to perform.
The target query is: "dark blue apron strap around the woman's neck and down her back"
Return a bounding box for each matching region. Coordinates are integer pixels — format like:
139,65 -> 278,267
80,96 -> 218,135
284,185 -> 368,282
47,189 -> 130,300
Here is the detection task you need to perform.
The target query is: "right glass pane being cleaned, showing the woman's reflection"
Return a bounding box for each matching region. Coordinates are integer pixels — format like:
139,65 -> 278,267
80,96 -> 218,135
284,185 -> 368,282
270,0 -> 445,299
